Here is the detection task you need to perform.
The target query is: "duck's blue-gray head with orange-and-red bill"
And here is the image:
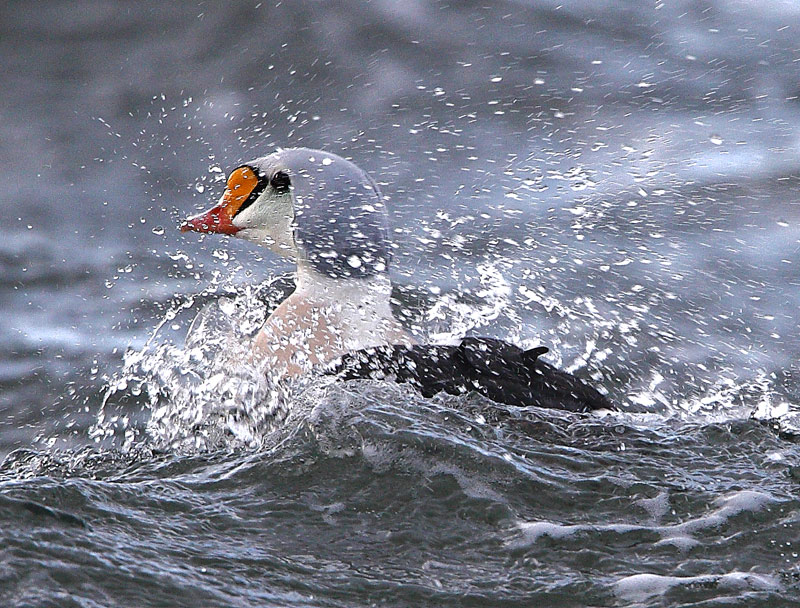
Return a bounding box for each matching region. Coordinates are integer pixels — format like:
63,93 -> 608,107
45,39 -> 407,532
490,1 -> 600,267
181,148 -> 391,278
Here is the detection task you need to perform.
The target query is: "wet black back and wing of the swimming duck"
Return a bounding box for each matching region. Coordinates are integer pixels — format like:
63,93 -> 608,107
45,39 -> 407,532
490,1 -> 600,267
326,338 -> 615,412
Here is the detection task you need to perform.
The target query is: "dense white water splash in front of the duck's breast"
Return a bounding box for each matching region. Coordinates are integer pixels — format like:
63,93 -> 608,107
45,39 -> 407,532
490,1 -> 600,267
91,277 -> 292,450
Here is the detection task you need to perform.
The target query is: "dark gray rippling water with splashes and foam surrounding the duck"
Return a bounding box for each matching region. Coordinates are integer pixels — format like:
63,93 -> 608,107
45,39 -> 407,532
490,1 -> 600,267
0,0 -> 800,607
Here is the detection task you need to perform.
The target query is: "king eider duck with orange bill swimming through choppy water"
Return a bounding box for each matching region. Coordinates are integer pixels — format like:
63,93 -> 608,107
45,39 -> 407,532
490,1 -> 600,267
181,148 -> 613,412
